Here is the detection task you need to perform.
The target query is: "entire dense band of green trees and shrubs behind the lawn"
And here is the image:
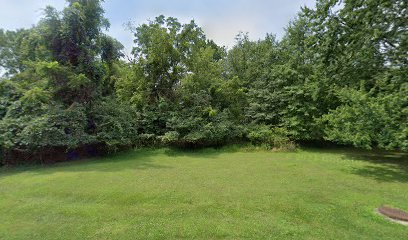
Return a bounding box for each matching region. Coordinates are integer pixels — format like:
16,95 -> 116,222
0,0 -> 408,163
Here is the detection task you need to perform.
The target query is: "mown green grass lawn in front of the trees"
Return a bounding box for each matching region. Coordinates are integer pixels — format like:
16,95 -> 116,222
0,148 -> 408,240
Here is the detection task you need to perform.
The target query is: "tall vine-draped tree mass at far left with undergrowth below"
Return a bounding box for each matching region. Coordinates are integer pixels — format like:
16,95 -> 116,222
0,0 -> 129,163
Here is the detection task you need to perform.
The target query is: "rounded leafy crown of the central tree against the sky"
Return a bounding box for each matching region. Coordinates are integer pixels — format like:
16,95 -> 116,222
133,16 -> 222,102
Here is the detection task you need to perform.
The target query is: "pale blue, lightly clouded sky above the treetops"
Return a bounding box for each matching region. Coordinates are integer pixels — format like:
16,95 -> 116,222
0,0 -> 315,52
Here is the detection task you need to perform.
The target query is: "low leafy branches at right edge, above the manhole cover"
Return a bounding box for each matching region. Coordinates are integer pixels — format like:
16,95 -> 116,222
323,87 -> 408,150
